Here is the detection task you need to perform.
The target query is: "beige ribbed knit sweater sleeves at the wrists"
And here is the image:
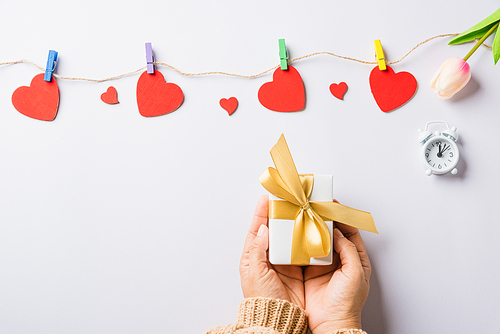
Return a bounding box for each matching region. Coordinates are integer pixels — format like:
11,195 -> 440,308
205,297 -> 366,334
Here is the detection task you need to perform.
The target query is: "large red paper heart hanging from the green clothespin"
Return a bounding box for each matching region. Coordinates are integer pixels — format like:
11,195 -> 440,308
258,66 -> 306,112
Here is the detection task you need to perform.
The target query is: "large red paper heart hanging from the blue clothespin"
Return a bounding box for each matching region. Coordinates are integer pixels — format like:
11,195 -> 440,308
12,73 -> 59,121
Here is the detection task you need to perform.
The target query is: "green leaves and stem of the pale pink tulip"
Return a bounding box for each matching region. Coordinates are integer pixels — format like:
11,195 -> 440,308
448,9 -> 500,64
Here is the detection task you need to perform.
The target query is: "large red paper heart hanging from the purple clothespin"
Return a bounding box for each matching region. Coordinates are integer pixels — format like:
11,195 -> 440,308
137,70 -> 184,117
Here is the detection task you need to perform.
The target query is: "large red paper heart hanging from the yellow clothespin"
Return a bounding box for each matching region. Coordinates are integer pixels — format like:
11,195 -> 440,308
370,66 -> 417,112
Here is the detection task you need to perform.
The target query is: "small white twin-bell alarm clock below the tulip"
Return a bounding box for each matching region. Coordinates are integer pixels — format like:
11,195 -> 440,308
418,121 -> 460,175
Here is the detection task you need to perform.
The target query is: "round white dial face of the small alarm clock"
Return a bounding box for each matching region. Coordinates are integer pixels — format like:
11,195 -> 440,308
424,137 -> 459,174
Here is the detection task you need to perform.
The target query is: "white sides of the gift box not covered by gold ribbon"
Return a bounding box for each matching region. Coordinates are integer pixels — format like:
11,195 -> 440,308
269,175 -> 333,265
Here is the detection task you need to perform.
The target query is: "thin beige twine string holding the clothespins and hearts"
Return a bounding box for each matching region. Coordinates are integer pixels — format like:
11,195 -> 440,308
0,34 -> 492,82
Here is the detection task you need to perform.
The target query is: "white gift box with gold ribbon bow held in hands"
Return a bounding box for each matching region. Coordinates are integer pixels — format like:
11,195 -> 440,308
259,135 -> 378,266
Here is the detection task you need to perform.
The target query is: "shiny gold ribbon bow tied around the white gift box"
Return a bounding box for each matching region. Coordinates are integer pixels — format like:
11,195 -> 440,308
259,135 -> 378,265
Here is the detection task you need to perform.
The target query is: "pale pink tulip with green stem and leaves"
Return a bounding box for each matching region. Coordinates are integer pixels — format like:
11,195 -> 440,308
431,9 -> 500,100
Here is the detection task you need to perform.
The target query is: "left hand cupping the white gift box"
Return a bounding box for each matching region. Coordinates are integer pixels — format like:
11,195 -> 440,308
240,196 -> 305,309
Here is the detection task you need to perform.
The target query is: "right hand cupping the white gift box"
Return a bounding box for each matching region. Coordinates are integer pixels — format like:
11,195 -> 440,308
304,224 -> 371,334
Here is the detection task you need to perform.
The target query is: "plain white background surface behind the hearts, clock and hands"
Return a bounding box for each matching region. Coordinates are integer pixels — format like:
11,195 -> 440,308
0,0 -> 500,334
